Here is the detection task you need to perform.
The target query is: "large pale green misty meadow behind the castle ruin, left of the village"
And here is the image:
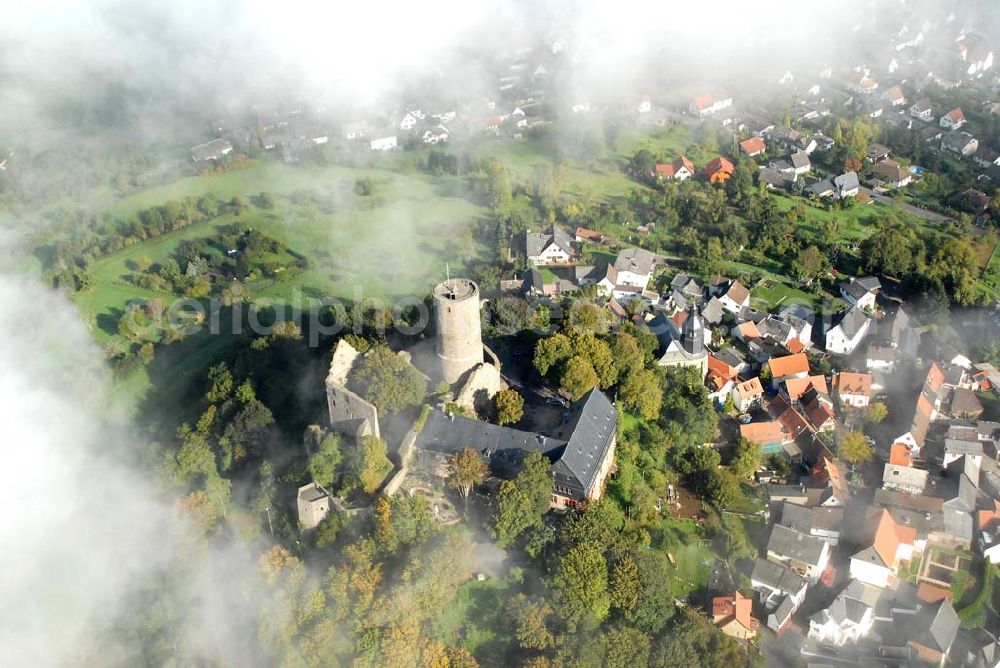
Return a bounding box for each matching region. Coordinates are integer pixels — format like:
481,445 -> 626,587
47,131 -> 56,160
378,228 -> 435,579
68,167 -> 484,348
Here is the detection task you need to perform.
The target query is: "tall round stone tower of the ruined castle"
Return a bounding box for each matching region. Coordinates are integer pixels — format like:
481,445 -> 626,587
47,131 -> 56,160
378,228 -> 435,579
434,278 -> 483,383
